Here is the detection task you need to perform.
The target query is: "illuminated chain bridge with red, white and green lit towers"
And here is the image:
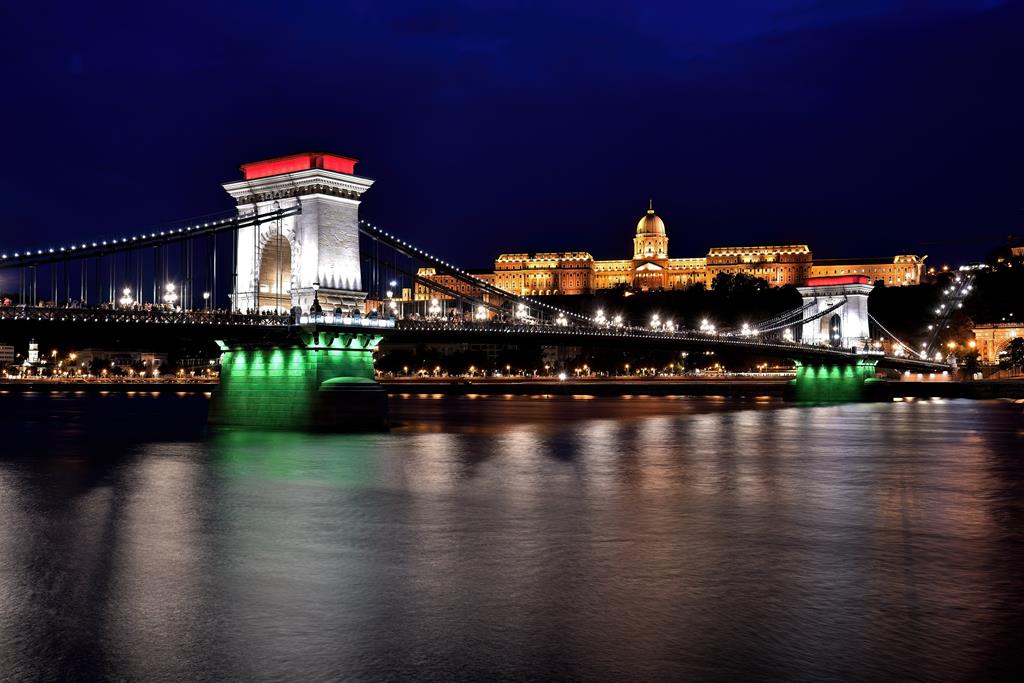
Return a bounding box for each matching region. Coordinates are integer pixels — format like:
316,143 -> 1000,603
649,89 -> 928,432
0,153 -> 950,429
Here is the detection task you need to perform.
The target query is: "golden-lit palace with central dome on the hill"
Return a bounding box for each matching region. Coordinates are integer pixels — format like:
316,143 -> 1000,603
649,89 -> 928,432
416,206 -> 927,301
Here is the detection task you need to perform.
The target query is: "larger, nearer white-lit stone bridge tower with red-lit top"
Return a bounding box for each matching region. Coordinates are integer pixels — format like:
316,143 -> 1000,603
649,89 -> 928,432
223,152 -> 373,312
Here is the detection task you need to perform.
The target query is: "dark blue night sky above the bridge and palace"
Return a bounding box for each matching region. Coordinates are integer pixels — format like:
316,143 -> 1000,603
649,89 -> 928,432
0,0 -> 1024,266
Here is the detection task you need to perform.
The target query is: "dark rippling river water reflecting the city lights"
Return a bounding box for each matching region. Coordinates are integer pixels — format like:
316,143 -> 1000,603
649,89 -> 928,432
0,394 -> 1024,681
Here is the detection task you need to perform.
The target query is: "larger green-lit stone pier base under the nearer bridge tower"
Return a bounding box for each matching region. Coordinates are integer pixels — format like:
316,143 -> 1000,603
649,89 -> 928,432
210,326 -> 388,431
